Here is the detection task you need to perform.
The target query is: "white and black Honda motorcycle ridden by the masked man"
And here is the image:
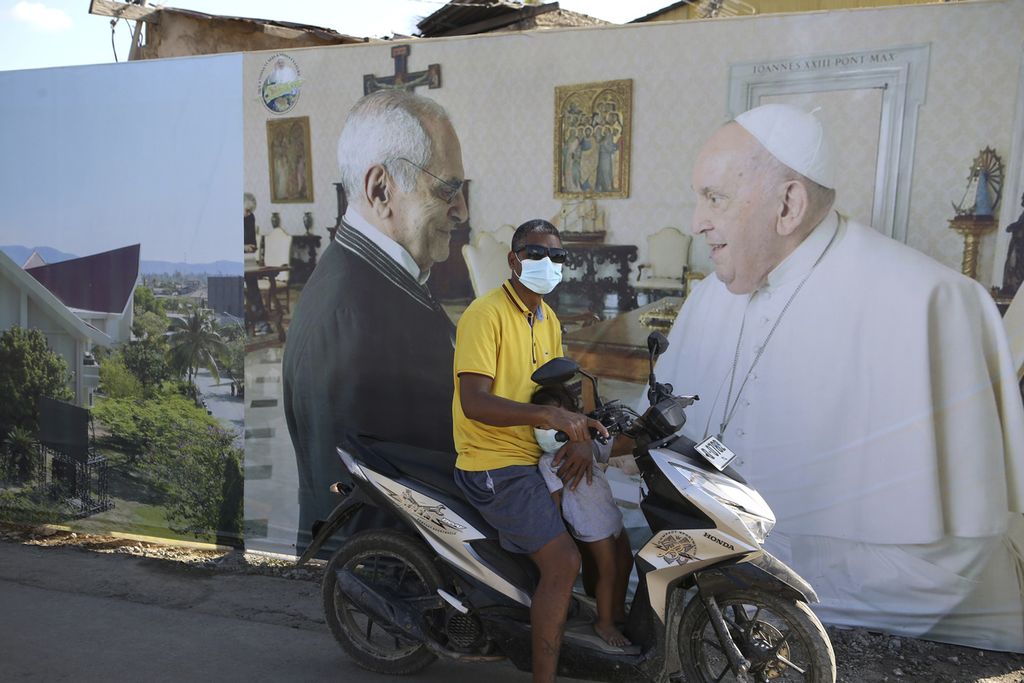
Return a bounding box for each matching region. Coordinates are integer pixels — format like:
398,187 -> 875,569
298,332 -> 836,683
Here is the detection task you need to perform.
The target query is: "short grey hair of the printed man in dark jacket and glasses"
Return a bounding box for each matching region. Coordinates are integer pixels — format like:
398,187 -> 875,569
338,90 -> 450,202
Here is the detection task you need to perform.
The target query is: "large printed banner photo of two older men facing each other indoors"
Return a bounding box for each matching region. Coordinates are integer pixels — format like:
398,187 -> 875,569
237,5 -> 1024,663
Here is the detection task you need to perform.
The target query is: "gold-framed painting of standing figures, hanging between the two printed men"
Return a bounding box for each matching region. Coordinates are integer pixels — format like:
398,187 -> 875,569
554,79 -> 633,199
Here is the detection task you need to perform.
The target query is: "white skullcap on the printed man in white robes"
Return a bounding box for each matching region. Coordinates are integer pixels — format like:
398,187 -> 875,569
735,104 -> 836,188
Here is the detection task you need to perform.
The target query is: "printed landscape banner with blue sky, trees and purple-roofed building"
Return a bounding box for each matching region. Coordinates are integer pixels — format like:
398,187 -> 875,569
0,57 -> 245,546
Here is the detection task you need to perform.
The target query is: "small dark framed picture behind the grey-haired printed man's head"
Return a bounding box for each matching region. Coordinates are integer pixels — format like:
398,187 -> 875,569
266,116 -> 313,204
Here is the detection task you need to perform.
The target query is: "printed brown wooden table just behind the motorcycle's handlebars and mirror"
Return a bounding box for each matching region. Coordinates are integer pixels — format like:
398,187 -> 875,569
562,297 -> 683,383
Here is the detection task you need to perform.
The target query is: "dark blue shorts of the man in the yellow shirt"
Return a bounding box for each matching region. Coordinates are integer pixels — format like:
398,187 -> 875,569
455,465 -> 566,555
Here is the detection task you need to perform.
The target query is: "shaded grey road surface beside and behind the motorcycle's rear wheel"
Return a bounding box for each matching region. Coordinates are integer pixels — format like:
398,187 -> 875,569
0,542 -> 529,683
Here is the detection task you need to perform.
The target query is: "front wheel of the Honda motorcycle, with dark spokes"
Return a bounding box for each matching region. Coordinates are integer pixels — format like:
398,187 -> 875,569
679,591 -> 836,683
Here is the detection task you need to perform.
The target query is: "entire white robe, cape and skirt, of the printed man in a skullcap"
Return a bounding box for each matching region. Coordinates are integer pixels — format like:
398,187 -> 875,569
657,213 -> 1024,651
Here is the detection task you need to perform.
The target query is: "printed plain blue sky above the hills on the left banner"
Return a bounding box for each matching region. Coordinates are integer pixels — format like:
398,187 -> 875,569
0,54 -> 243,263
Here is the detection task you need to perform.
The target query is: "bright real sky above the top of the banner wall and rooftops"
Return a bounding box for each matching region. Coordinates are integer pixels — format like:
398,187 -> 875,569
0,0 -> 672,71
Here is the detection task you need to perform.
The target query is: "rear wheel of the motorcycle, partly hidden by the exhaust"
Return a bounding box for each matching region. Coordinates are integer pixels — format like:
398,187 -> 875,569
323,531 -> 443,675
